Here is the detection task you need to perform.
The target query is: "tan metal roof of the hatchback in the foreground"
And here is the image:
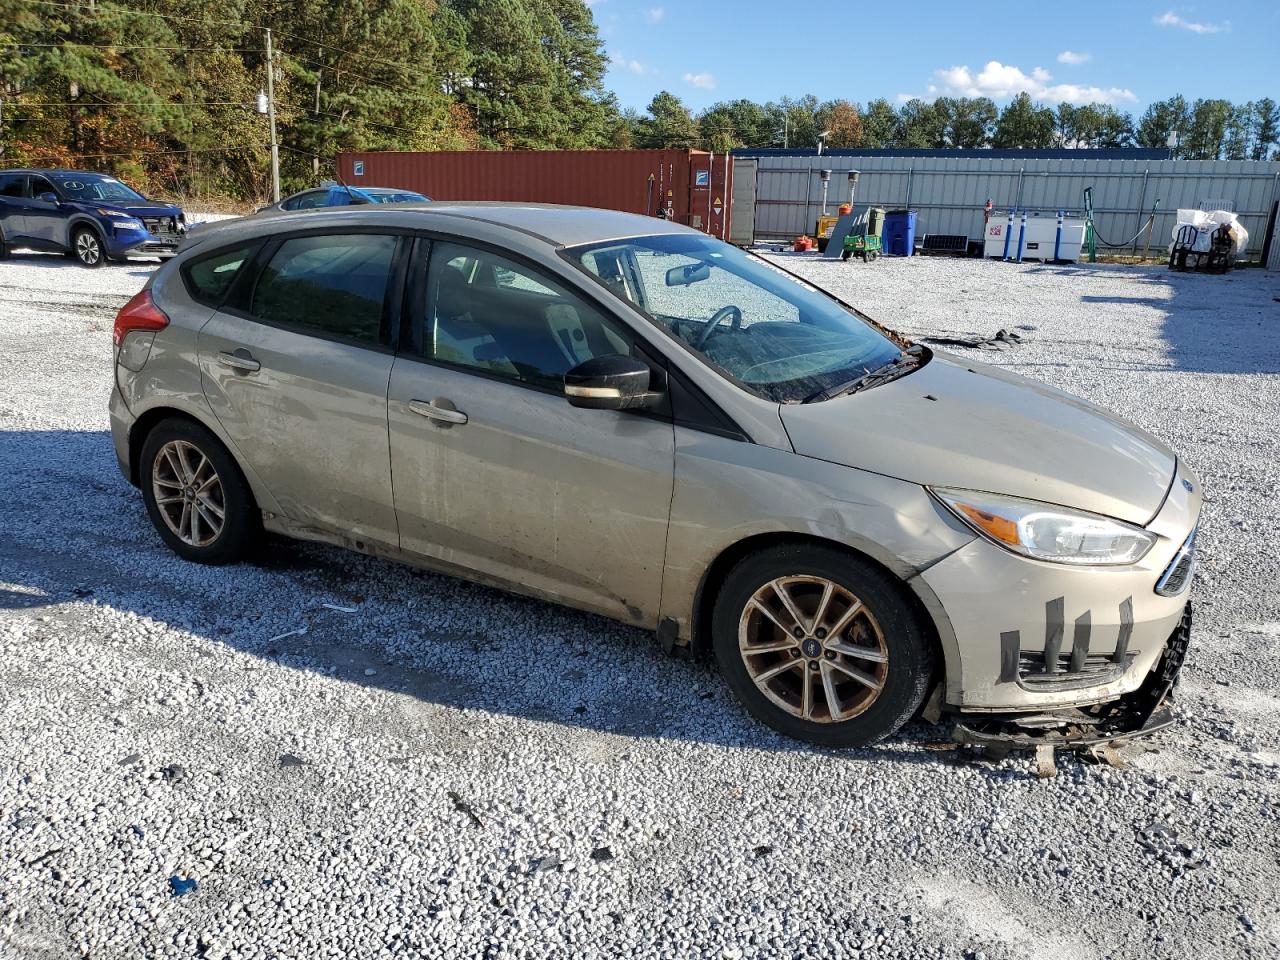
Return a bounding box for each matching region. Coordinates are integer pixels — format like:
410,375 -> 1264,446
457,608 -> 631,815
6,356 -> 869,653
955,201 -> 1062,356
193,200 -> 705,247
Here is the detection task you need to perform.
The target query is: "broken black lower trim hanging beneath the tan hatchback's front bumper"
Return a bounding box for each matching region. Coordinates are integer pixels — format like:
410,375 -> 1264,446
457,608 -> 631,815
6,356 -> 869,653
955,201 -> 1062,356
951,603 -> 1192,753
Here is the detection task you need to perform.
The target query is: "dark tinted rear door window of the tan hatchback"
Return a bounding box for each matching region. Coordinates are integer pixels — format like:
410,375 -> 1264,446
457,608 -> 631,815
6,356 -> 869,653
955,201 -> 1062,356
250,233 -> 397,346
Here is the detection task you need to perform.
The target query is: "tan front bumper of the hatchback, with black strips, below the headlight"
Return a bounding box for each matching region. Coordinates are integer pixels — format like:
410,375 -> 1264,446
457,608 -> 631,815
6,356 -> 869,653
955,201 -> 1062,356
922,465 -> 1201,713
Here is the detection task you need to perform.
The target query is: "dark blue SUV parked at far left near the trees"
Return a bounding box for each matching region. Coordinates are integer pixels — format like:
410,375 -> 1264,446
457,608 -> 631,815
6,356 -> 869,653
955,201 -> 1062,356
0,170 -> 187,266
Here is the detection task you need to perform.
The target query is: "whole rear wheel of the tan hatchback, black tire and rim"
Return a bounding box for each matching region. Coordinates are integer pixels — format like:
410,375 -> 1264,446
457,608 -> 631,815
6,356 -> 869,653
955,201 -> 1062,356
138,417 -> 261,564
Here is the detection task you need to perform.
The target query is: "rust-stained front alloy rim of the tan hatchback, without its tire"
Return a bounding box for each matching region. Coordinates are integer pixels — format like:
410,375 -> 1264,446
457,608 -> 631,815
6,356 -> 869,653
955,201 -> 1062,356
737,576 -> 888,723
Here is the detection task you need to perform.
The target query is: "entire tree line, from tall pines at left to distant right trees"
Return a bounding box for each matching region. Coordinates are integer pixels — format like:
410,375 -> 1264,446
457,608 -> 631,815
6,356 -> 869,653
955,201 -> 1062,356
0,0 -> 1280,197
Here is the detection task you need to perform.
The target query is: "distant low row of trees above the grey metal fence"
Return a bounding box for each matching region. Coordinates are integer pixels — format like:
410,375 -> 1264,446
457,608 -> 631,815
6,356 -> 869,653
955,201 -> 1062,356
629,91 -> 1280,160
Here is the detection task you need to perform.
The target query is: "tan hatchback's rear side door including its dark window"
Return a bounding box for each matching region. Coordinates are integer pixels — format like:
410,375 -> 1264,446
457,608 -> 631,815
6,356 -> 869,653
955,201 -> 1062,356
198,232 -> 404,547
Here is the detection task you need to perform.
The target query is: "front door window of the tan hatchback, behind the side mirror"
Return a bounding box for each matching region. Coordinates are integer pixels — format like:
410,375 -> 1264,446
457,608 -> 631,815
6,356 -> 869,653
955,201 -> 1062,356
416,243 -> 632,389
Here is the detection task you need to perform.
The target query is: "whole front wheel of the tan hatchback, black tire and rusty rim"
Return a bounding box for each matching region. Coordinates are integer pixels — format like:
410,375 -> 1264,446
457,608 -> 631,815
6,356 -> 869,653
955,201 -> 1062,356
712,545 -> 934,748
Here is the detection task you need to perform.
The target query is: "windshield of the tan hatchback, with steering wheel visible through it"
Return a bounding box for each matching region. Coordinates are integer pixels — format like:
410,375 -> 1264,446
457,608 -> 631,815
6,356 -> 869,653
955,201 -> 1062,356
564,234 -> 901,403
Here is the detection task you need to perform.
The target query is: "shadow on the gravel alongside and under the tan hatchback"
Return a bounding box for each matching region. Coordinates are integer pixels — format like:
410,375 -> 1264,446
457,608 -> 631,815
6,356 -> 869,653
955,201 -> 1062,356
0,431 -> 972,778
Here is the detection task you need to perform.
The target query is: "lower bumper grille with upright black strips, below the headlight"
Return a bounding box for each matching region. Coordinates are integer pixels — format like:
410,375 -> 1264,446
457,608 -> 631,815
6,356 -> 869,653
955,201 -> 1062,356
1000,596 -> 1135,692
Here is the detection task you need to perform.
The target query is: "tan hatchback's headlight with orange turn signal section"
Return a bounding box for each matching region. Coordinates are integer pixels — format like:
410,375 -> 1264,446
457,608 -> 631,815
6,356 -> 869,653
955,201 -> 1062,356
931,489 -> 1157,566
